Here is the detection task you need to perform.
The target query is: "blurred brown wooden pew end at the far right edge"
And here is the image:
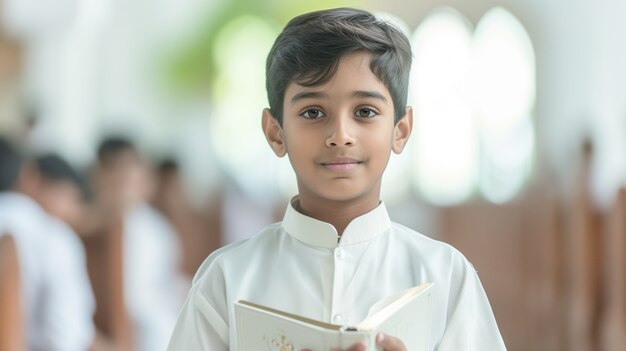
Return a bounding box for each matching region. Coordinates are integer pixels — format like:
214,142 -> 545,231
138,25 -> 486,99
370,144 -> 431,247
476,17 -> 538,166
598,188 -> 626,351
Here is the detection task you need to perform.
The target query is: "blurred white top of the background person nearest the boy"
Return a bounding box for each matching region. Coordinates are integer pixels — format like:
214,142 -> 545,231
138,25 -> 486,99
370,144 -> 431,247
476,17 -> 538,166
124,204 -> 189,351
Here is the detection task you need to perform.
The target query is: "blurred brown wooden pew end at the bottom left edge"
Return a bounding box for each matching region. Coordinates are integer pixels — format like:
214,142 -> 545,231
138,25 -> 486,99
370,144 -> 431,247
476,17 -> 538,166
0,234 -> 26,351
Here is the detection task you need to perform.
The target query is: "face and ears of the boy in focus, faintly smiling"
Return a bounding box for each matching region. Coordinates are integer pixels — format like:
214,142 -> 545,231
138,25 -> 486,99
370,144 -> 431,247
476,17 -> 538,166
263,52 -> 412,208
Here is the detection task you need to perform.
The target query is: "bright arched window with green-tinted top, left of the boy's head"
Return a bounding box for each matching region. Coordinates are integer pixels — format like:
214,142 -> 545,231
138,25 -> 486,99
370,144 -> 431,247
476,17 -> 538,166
211,15 -> 280,199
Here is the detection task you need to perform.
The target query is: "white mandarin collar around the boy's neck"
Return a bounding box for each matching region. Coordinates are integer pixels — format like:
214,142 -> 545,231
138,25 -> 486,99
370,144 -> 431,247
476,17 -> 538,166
282,196 -> 391,249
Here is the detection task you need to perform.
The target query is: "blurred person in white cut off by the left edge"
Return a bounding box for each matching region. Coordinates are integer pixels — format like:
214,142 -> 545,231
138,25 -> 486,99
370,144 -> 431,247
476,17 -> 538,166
0,138 -> 94,351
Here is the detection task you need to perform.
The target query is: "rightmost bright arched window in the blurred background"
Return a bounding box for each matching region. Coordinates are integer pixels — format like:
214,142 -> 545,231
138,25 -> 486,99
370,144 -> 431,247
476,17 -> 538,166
473,7 -> 536,203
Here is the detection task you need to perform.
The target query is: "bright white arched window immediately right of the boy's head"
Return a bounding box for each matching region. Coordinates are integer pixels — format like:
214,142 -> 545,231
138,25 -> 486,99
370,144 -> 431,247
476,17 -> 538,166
410,7 -> 479,205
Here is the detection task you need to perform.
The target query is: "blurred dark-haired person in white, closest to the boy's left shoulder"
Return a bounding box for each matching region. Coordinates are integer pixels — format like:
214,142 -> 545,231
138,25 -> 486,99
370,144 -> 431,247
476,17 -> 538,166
93,137 -> 188,351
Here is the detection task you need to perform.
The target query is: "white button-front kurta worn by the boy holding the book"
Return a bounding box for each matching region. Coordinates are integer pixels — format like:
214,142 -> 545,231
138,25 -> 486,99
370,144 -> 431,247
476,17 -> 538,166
169,199 -> 505,351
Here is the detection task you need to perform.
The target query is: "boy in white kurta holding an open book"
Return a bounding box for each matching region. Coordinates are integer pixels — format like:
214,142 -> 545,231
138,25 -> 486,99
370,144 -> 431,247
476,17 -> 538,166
170,9 -> 505,351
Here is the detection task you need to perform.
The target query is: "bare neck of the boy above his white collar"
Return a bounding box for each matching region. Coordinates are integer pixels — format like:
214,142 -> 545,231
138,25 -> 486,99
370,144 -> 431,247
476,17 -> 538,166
294,192 -> 380,236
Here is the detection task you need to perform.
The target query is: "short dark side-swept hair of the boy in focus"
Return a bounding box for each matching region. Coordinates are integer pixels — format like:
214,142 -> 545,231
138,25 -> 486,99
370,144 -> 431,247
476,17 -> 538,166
265,8 -> 412,124
